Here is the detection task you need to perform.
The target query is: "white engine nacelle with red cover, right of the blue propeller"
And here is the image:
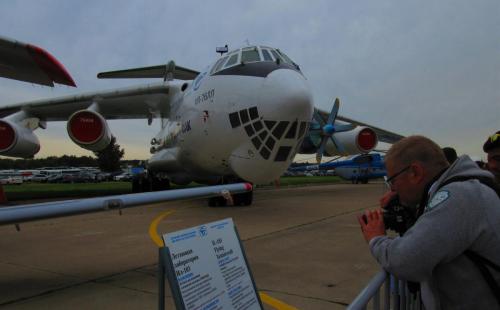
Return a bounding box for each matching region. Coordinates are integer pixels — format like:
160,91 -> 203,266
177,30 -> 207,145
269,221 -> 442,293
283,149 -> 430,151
325,127 -> 378,156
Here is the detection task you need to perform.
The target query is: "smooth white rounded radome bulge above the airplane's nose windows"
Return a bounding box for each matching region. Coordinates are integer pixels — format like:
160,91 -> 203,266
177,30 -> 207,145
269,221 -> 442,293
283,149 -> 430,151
260,69 -> 313,121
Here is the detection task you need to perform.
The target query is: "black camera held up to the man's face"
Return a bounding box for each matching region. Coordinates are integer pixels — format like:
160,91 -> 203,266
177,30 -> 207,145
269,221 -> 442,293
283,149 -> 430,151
383,195 -> 417,236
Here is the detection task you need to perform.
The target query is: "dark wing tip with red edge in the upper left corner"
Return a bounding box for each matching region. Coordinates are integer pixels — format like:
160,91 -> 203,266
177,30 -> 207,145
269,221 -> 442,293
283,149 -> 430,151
0,36 -> 76,87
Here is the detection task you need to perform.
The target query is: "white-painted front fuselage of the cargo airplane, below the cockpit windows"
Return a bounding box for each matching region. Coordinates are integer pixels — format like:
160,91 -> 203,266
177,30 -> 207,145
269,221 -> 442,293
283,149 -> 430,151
149,68 -> 313,184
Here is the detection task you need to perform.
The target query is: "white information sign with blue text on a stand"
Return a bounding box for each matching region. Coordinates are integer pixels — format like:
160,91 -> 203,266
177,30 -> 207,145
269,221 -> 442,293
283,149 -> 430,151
163,218 -> 262,310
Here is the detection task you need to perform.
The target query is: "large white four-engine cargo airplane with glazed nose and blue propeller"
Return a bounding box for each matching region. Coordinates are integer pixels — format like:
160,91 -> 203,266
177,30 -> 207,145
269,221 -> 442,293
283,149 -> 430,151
0,45 -> 402,205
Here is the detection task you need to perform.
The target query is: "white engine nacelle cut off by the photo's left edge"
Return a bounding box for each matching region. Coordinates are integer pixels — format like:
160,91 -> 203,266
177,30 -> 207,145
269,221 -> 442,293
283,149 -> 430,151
0,119 -> 40,158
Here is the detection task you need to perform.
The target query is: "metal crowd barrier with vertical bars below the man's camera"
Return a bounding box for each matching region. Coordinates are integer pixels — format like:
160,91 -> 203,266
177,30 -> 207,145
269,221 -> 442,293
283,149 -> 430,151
347,270 -> 423,310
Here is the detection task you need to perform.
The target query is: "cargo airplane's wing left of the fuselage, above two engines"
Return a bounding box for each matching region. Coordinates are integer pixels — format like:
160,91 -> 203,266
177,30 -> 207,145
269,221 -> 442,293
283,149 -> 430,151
0,83 -> 174,121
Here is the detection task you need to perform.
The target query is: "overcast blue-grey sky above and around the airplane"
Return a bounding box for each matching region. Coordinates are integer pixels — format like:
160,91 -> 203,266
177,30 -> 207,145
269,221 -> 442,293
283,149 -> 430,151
0,0 -> 500,159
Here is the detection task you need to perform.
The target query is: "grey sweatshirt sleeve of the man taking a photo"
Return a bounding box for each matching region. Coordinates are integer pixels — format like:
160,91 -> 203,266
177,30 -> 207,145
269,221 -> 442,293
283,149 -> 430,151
369,184 -> 482,281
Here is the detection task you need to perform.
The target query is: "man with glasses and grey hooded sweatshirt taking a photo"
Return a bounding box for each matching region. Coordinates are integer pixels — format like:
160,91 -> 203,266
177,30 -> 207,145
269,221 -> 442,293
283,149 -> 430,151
358,136 -> 500,309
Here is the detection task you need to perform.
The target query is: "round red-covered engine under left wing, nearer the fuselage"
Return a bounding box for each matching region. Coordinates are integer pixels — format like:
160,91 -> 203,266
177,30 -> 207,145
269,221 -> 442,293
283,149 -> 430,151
66,110 -> 111,152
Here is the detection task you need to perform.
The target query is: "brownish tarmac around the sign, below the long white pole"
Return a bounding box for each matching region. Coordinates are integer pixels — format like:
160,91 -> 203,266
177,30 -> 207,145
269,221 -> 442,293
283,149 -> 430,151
0,184 -> 384,309
